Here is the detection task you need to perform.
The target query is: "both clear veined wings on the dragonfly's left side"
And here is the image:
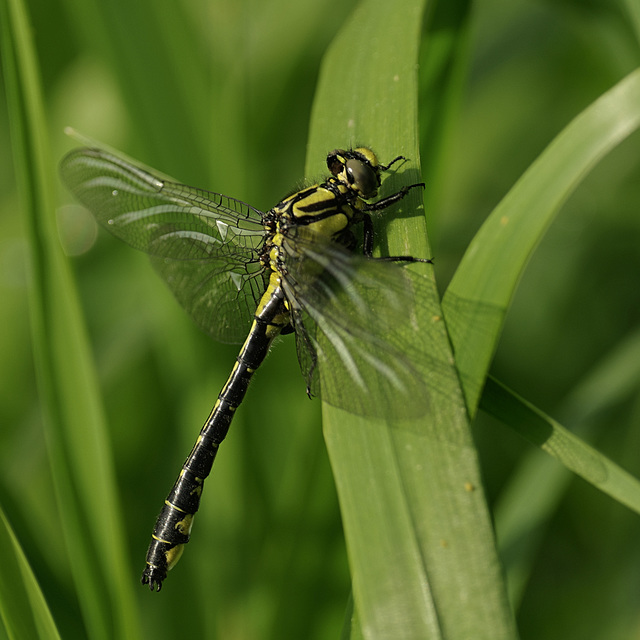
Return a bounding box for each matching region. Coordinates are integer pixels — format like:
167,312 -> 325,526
60,149 -> 265,342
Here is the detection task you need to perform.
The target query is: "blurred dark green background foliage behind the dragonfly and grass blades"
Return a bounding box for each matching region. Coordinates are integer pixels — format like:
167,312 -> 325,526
0,0 -> 640,640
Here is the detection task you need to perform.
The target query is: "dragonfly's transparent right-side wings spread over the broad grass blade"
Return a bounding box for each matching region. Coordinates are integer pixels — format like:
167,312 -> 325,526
283,229 -> 438,418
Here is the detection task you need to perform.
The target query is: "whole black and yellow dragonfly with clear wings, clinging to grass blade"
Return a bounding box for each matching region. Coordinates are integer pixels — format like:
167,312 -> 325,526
61,148 -> 430,591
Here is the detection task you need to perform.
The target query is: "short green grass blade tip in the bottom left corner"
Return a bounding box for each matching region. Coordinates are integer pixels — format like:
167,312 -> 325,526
0,508 -> 60,640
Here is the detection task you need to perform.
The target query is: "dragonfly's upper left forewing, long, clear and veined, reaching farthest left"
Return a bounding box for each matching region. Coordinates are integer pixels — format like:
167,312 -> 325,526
61,149 -> 264,261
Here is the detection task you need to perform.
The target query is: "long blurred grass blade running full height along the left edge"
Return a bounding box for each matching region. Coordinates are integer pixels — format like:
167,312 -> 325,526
0,0 -> 139,639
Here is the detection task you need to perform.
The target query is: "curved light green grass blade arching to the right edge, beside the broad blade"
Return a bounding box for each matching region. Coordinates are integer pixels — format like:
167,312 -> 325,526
442,70 -> 640,415
